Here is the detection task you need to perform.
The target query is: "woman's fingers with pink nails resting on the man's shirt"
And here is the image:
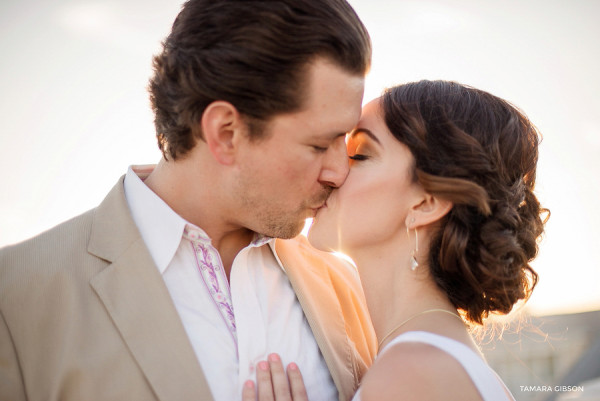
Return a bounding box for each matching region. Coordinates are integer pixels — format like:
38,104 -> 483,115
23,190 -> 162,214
242,354 -> 308,401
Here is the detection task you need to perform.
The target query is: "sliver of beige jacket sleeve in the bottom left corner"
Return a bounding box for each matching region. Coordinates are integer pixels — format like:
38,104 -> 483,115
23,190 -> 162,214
0,310 -> 27,401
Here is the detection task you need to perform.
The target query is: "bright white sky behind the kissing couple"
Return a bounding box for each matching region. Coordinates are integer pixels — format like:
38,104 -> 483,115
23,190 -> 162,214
0,0 -> 600,314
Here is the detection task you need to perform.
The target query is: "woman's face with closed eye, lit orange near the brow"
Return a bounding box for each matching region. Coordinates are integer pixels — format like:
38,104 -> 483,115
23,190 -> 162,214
308,99 -> 419,256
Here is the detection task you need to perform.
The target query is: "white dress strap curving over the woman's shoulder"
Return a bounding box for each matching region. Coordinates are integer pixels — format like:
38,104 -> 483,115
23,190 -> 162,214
352,331 -> 514,401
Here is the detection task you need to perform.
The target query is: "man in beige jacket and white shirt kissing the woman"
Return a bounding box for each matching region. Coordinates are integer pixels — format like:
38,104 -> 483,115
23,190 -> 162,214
0,0 -> 375,401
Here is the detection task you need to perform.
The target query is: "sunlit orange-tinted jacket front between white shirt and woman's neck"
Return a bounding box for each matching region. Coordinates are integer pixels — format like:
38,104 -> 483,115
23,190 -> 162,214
275,236 -> 375,400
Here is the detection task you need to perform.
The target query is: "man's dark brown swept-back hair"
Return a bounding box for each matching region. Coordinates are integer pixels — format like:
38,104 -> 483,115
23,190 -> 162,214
149,0 -> 371,160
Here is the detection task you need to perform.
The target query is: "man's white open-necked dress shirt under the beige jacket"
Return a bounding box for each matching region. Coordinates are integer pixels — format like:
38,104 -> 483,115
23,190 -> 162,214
125,166 -> 337,401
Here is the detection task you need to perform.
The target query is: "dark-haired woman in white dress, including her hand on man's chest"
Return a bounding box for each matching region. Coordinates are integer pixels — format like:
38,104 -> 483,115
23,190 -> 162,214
244,81 -> 547,401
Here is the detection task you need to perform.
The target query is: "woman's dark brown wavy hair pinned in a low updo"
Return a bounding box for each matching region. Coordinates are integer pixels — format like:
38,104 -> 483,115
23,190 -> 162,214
382,81 -> 548,324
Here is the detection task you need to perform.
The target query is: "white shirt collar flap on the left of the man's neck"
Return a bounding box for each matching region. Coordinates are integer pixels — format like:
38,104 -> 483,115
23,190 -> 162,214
124,166 -> 187,274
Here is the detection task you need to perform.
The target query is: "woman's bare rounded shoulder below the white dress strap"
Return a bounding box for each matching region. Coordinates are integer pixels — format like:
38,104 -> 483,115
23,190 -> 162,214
361,334 -> 481,401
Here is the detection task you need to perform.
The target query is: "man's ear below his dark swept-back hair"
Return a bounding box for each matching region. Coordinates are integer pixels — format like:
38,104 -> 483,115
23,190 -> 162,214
200,100 -> 246,165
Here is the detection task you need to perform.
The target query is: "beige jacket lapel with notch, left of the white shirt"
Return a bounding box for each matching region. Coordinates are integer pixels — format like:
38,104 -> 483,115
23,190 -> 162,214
88,178 -> 213,401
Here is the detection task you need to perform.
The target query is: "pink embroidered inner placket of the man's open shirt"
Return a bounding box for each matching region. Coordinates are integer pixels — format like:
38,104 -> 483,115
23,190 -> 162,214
183,224 -> 237,350
